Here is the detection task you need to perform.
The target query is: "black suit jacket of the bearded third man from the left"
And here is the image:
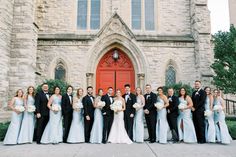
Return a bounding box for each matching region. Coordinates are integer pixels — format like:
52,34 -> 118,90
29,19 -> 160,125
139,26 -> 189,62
82,95 -> 95,118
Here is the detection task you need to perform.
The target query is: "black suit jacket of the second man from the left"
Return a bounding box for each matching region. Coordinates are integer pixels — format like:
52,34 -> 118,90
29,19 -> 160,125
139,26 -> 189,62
61,93 -> 73,115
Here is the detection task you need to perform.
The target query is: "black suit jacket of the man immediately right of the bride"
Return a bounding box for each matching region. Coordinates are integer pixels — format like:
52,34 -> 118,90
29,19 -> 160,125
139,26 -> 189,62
123,93 -> 137,115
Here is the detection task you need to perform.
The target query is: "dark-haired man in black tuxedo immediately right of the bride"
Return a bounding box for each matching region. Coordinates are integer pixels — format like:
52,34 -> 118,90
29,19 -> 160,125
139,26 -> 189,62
123,84 -> 136,140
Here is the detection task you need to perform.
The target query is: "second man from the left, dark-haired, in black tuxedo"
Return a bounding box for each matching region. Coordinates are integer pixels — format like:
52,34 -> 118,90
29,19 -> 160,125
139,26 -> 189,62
61,86 -> 73,143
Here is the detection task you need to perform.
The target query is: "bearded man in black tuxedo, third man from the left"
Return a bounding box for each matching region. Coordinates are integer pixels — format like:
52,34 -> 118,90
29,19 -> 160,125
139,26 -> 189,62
82,86 -> 94,143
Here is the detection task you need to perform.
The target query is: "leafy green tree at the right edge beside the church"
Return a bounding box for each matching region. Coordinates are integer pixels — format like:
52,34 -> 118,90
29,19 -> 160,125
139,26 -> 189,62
211,26 -> 236,94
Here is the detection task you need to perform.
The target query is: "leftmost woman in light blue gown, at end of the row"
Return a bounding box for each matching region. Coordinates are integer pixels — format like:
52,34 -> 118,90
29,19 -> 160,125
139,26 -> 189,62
3,89 -> 24,145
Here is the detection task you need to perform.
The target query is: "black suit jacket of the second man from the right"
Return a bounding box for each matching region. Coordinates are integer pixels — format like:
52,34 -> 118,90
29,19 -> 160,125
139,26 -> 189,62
167,95 -> 179,116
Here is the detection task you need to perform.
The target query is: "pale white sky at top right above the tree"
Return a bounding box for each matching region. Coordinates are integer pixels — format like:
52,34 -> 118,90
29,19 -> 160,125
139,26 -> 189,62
208,0 -> 230,34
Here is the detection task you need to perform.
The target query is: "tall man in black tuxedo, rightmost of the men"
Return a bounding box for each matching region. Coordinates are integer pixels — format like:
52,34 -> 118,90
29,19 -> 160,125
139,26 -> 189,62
192,80 -> 207,143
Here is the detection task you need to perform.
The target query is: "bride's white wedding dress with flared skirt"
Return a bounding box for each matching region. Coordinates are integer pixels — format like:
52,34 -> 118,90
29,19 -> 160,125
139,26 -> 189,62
108,100 -> 133,144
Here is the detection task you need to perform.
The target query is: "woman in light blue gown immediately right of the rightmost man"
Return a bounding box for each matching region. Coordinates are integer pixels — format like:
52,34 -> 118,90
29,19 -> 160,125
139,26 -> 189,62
204,87 -> 216,143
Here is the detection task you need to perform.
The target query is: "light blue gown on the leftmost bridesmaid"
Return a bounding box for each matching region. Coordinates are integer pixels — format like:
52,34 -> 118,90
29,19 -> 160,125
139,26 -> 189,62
3,97 -> 24,145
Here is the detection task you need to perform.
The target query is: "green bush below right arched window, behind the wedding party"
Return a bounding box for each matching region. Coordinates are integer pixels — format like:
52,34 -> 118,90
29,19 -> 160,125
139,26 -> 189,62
163,82 -> 194,96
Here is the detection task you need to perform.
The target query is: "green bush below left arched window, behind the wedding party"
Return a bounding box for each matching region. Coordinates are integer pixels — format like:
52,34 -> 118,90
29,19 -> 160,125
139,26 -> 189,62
36,79 -> 68,94
